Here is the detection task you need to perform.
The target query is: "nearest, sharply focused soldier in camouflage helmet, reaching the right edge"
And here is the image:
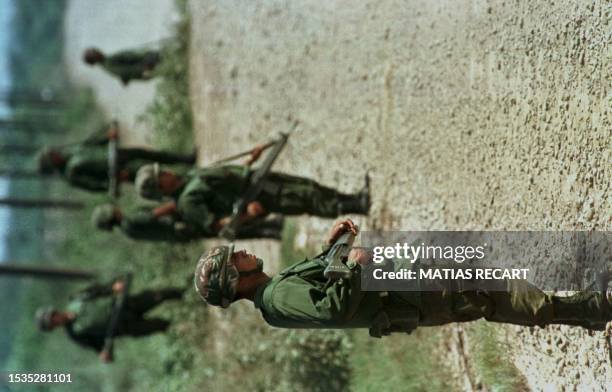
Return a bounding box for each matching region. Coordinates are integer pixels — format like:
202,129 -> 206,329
194,220 -> 612,337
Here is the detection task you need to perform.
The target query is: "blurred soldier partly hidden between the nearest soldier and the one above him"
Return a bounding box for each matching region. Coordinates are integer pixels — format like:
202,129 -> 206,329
91,204 -> 283,242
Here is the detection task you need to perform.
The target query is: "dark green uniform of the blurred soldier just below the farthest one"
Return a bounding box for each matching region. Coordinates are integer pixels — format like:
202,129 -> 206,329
47,127 -> 195,192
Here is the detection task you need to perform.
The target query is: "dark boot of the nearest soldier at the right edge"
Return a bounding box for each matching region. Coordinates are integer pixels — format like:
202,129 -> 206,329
552,291 -> 612,331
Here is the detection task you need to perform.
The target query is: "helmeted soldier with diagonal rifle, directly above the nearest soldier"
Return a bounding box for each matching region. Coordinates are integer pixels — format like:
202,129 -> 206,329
135,145 -> 370,232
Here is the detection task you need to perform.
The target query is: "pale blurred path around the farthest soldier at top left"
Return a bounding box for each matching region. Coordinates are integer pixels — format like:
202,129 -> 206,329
64,0 -> 177,144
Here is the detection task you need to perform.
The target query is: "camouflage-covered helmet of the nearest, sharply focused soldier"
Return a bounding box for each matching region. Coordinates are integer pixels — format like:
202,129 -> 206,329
194,245 -> 240,308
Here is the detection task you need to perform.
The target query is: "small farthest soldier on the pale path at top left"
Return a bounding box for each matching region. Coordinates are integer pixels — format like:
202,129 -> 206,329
83,48 -> 160,85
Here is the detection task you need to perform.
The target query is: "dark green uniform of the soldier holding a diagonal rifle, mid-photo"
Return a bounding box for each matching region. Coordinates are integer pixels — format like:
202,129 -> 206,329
174,165 -> 367,230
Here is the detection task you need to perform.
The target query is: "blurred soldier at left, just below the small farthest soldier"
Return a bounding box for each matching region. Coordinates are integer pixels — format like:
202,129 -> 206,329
38,126 -> 196,192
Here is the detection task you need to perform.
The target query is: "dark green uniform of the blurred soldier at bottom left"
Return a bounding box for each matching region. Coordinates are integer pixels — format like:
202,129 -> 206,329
65,284 -> 183,351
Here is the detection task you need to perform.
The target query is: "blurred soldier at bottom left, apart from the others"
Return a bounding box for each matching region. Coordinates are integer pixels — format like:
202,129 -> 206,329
36,280 -> 185,362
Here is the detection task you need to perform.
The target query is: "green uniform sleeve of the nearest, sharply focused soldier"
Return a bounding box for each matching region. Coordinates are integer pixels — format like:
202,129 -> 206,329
271,276 -> 350,328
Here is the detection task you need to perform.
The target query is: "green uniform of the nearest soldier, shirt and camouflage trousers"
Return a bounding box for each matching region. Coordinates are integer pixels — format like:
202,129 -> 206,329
254,255 -> 612,337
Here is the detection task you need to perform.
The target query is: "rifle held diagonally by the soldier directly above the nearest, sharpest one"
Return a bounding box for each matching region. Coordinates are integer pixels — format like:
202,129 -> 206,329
219,132 -> 297,241
